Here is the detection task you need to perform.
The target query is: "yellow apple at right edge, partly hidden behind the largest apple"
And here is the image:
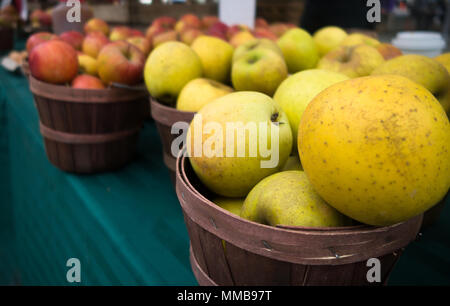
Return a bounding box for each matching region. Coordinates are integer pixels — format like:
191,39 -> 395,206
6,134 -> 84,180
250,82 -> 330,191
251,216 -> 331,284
372,54 -> 450,114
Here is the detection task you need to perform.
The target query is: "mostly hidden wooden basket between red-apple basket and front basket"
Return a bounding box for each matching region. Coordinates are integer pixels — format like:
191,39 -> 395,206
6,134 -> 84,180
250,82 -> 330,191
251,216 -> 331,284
150,98 -> 195,185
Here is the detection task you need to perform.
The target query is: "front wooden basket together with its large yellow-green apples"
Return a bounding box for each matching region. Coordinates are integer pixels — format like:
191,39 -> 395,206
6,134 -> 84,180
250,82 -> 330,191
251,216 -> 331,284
176,70 -> 450,285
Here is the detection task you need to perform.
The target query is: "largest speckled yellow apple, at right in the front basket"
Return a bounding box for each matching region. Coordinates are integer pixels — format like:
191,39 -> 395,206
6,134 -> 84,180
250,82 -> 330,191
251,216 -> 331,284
298,75 -> 450,226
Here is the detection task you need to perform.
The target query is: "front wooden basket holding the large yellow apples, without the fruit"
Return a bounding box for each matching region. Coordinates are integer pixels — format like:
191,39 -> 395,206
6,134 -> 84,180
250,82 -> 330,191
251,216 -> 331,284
176,155 -> 422,286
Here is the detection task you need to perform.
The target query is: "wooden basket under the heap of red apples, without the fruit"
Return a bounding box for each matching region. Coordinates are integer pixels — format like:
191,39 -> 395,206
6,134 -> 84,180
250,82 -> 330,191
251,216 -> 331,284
29,76 -> 147,173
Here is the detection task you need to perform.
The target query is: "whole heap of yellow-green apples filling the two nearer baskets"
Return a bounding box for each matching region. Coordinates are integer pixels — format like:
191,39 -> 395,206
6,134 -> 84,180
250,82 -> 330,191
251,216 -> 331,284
144,20 -> 450,227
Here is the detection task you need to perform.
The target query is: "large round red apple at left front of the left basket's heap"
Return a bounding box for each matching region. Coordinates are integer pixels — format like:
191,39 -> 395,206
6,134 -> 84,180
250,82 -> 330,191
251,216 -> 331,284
29,40 -> 78,84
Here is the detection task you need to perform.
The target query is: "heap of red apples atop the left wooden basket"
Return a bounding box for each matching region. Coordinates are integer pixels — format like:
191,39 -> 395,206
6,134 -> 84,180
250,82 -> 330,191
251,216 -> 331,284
26,18 -> 151,89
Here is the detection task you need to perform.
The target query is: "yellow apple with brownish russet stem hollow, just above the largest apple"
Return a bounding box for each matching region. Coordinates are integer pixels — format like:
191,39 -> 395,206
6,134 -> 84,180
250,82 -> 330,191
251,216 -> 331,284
317,44 -> 384,78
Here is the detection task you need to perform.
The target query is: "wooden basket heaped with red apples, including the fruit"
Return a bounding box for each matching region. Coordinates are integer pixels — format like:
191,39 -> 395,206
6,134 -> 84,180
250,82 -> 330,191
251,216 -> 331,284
27,23 -> 148,173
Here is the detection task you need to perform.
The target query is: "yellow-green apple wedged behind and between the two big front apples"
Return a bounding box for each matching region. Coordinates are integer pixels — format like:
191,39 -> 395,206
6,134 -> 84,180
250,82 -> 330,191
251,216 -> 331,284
273,69 -> 349,150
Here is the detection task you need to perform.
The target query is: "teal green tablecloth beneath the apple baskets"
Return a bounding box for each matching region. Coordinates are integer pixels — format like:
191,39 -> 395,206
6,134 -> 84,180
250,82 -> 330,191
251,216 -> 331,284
0,42 -> 450,285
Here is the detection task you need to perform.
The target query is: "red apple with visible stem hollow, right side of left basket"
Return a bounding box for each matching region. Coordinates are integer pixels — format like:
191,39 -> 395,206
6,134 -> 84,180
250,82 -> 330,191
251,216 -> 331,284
98,40 -> 146,85
